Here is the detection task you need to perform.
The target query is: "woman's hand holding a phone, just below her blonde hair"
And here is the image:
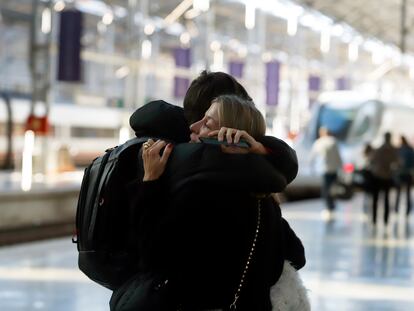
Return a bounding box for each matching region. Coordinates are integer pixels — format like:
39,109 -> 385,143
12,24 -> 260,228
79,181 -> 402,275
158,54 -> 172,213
208,127 -> 267,155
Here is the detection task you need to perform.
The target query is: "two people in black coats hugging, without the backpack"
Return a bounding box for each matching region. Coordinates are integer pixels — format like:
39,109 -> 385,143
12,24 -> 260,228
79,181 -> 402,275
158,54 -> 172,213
110,71 -> 309,311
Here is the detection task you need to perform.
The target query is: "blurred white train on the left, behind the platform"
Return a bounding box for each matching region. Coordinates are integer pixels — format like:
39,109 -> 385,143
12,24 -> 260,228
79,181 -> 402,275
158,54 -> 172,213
0,99 -> 133,171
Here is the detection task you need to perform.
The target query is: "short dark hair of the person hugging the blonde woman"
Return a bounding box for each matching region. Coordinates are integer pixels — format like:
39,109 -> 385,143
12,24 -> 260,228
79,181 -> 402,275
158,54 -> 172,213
183,70 -> 251,124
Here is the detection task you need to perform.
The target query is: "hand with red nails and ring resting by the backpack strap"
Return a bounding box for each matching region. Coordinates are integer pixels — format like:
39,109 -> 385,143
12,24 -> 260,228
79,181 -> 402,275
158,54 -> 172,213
142,139 -> 173,181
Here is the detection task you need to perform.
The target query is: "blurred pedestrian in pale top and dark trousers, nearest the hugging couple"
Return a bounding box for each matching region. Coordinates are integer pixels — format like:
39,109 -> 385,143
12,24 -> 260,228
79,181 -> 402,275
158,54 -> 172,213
311,127 -> 342,219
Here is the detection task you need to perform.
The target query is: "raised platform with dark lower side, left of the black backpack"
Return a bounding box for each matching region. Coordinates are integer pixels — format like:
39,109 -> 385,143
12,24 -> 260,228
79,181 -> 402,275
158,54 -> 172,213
0,170 -> 83,245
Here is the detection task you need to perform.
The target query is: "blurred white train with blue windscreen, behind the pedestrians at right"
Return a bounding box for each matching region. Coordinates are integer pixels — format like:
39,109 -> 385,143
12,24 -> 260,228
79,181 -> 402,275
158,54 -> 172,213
291,91 -> 414,192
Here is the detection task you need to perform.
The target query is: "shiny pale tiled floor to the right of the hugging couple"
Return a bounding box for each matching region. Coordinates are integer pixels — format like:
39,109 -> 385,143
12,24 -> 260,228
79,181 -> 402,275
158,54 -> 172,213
283,196 -> 414,311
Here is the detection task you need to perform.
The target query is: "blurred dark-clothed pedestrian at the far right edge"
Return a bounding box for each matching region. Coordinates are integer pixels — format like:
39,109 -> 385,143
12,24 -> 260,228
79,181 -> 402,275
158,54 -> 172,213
395,135 -> 414,216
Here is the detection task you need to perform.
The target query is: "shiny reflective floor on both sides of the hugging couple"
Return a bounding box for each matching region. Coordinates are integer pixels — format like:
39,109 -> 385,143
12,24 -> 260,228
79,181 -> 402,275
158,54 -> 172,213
0,196 -> 414,311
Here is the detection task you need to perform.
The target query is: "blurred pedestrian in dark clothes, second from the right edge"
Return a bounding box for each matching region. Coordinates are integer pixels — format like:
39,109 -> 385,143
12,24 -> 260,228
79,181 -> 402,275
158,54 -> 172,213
371,132 -> 399,225
